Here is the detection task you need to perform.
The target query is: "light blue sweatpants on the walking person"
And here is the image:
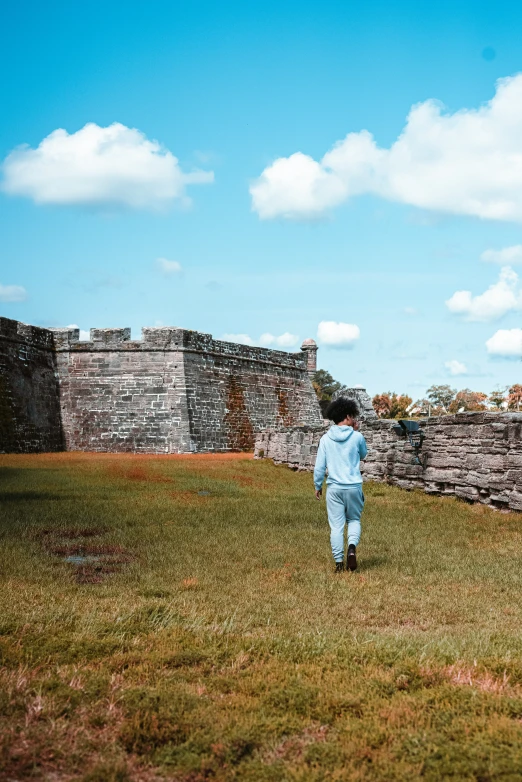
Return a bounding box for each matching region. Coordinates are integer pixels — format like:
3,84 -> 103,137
326,483 -> 364,562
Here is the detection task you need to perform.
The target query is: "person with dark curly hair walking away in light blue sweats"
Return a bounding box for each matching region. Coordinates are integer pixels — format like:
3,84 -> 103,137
314,397 -> 368,573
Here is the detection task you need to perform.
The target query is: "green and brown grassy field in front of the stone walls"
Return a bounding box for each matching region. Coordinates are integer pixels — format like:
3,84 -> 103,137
0,453 -> 522,782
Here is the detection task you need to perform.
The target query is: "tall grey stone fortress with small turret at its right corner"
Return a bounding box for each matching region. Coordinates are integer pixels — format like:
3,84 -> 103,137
0,318 -> 322,453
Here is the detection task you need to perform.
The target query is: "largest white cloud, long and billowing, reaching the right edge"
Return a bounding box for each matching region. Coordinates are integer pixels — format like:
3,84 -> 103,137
250,74 -> 522,222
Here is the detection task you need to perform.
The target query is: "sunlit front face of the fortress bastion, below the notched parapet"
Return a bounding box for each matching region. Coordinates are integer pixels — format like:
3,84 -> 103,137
49,329 -> 195,453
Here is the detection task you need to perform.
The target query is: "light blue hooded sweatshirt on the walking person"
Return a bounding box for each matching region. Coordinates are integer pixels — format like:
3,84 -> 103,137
314,424 -> 368,491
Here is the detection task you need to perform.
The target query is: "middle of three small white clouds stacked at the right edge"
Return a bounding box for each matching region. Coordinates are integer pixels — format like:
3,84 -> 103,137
446,266 -> 522,322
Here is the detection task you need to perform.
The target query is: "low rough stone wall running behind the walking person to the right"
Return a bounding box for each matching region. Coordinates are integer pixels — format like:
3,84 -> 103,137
255,413 -> 522,510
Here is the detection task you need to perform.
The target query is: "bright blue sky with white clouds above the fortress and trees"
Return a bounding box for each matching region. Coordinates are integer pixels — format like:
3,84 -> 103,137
0,0 -> 522,398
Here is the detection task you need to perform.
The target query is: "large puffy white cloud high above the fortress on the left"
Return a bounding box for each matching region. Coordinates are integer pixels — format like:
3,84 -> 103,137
2,122 -> 214,209
